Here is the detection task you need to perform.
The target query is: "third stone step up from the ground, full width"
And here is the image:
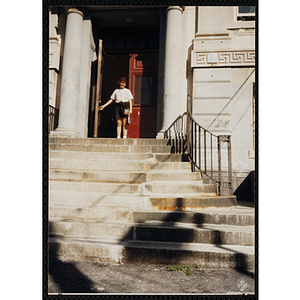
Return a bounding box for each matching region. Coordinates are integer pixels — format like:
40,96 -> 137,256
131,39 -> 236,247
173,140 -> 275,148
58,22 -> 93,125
49,206 -> 255,226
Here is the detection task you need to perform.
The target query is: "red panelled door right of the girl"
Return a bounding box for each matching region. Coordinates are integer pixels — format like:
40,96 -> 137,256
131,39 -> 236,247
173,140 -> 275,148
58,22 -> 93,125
128,53 -> 157,138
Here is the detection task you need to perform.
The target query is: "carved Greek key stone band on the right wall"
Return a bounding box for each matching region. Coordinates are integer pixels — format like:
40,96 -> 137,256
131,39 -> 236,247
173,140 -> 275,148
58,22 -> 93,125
191,50 -> 255,68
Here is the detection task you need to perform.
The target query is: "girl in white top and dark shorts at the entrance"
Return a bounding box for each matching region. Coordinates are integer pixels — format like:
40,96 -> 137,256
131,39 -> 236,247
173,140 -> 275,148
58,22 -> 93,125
99,77 -> 133,139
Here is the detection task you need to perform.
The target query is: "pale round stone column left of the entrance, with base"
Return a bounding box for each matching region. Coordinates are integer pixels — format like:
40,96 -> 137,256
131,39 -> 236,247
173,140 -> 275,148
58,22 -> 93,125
52,8 -> 83,137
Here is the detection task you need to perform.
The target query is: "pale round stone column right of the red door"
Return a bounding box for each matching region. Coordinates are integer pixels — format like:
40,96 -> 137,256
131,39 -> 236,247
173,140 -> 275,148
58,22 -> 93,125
158,6 -> 183,137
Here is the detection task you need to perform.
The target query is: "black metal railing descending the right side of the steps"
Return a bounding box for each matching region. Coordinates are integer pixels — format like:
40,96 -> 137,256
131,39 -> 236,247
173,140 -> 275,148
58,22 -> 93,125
164,95 -> 232,195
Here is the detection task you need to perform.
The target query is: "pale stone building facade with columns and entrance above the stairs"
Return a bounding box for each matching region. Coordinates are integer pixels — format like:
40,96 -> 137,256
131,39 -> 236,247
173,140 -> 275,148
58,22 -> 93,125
49,6 -> 255,195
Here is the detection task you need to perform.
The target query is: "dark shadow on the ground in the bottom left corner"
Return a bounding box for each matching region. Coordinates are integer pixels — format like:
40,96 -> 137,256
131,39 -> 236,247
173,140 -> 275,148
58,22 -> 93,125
48,222 -> 95,293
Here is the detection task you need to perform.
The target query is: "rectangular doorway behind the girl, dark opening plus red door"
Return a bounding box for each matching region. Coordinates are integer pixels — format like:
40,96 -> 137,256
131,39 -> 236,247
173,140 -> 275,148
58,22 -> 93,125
98,53 -> 158,138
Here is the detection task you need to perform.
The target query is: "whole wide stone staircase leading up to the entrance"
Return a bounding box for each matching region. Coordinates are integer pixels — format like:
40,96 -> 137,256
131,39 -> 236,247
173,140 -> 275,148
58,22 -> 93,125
49,138 -> 255,272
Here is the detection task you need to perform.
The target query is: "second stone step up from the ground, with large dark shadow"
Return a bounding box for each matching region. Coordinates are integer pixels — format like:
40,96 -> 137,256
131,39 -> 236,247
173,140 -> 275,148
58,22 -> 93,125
52,218 -> 254,246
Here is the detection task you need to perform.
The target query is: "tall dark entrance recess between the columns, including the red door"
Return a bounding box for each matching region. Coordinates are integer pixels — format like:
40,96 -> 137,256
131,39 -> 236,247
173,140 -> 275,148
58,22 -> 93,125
88,8 -> 164,138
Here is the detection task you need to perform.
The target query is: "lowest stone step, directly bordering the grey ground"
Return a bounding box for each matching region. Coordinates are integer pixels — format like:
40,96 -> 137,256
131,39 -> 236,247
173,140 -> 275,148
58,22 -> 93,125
48,237 -> 255,271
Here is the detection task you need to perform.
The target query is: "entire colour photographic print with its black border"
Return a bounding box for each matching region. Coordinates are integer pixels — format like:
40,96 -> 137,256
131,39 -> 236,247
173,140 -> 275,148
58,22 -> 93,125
43,1 -> 258,299
